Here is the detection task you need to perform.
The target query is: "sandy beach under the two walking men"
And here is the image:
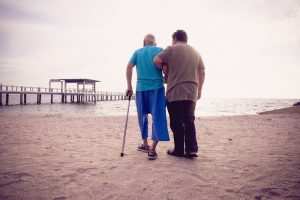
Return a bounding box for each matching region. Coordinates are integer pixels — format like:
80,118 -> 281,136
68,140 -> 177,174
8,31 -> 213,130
0,107 -> 300,200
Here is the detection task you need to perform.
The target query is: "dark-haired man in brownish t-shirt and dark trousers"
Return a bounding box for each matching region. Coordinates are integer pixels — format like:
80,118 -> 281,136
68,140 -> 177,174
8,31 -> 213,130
153,30 -> 205,158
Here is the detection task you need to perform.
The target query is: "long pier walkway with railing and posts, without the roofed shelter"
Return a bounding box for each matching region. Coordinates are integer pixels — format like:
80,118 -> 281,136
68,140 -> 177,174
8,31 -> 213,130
0,84 -> 134,105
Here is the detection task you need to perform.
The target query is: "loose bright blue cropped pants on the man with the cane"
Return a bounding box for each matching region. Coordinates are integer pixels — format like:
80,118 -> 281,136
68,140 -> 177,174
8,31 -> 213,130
136,87 -> 170,141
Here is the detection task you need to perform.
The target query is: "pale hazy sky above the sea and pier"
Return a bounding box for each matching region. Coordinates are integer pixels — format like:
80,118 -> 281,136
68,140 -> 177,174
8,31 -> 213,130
0,0 -> 300,98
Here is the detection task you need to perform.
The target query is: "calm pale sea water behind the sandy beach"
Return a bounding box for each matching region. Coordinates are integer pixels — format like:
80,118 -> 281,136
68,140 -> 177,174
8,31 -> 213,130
0,95 -> 299,116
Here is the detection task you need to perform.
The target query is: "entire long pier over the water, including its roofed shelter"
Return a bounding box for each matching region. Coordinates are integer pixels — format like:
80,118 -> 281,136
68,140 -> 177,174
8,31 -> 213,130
0,79 -> 134,106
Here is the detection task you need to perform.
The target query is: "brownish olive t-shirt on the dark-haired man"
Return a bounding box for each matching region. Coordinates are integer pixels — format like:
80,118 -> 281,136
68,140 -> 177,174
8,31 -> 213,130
158,43 -> 204,102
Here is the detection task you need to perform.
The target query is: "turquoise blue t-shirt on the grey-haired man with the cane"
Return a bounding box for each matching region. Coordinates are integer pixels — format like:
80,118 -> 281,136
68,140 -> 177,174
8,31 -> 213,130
130,46 -> 164,91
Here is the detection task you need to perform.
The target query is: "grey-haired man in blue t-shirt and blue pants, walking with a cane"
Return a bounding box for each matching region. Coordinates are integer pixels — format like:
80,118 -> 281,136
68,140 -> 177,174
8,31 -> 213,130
126,34 -> 170,160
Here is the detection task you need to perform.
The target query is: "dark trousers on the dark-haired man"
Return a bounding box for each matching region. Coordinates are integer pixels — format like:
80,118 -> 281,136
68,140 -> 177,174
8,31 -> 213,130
167,100 -> 198,155
